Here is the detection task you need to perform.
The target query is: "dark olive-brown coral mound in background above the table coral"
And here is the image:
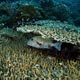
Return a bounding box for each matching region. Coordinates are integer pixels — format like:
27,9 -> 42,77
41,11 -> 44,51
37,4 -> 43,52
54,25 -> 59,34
19,5 -> 41,18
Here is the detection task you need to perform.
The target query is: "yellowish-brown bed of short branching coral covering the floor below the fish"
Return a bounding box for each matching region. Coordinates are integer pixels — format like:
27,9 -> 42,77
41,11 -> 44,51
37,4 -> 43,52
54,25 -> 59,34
0,27 -> 80,80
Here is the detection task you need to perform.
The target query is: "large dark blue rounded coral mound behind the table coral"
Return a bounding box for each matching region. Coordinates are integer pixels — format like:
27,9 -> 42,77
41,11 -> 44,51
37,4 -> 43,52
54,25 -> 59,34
40,0 -> 70,21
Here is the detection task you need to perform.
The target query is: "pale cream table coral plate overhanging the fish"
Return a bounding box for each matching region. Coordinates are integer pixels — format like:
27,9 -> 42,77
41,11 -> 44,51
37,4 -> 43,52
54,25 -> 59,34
17,25 -> 80,46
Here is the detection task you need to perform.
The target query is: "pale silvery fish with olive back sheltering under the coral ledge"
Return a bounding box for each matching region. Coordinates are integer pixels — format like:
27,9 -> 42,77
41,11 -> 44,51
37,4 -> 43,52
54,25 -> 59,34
27,36 -> 62,51
